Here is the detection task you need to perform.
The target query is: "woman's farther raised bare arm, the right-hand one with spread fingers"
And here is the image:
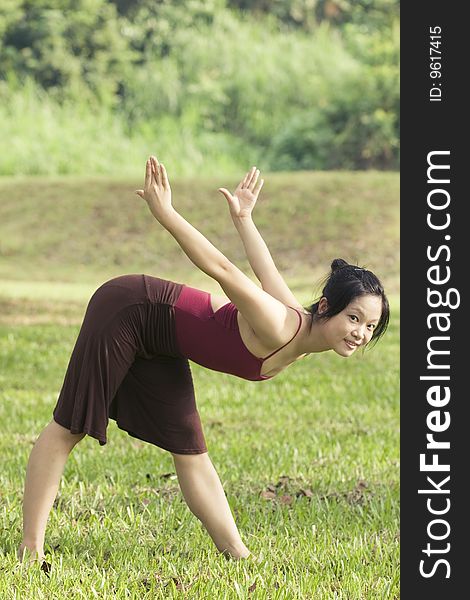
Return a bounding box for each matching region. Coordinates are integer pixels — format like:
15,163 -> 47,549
219,167 -> 303,310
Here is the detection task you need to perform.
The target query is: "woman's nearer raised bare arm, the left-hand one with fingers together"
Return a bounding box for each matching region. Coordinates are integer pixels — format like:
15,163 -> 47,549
136,158 -> 295,349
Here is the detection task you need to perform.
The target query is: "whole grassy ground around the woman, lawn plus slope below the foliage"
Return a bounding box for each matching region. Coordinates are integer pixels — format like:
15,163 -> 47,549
0,173 -> 399,600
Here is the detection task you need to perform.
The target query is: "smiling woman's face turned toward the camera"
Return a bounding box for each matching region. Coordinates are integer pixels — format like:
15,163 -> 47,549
318,294 -> 382,357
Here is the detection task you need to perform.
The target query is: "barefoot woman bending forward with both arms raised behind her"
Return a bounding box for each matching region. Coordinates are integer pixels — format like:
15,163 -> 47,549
18,157 -> 389,560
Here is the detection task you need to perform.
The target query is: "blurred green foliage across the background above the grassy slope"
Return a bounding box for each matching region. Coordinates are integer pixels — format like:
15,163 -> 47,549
0,0 -> 399,174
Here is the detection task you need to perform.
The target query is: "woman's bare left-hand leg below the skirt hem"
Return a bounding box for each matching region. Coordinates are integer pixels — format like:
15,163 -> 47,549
17,420 -> 86,560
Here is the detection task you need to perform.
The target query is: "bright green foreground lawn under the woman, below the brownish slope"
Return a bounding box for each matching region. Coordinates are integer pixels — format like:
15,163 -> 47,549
0,307 -> 399,599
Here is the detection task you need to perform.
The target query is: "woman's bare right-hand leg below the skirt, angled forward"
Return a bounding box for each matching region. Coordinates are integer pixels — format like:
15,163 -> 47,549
172,452 -> 251,558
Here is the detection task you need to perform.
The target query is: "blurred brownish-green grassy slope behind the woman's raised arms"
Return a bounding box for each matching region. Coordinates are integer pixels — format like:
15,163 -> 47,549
0,171 -> 399,310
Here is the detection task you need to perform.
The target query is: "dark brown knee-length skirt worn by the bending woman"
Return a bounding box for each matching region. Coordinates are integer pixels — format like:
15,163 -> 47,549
53,275 -> 207,454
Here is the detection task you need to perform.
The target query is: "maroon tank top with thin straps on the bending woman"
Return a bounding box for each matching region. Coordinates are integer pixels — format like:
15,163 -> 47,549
174,285 -> 302,381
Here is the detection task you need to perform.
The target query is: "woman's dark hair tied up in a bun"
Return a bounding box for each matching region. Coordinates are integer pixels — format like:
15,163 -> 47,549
307,258 -> 390,345
